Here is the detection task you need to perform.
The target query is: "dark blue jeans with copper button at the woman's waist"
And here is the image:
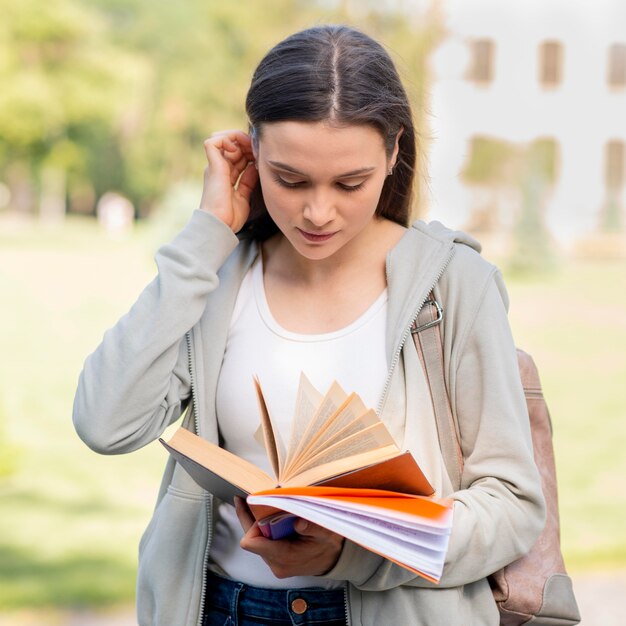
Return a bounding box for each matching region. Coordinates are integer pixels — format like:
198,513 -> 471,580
202,572 -> 347,626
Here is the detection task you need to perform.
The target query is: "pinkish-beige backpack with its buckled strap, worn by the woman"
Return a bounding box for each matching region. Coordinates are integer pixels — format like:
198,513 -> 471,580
411,294 -> 580,626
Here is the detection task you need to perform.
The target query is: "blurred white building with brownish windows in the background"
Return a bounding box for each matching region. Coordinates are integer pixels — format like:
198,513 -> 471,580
429,0 -> 626,248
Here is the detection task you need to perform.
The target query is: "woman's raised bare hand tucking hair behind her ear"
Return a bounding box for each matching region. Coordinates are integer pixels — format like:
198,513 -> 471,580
200,130 -> 258,233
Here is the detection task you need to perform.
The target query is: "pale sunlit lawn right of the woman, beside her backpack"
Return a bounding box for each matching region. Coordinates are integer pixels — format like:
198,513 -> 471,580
502,260 -> 626,569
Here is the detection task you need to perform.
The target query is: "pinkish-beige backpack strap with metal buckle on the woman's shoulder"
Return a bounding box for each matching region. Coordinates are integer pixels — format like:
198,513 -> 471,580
411,292 -> 463,489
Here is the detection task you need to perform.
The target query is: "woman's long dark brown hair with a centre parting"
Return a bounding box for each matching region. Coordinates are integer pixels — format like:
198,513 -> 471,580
240,25 -> 416,240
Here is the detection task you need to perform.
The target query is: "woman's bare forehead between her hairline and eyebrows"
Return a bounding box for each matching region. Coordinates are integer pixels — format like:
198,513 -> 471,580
259,122 -> 386,171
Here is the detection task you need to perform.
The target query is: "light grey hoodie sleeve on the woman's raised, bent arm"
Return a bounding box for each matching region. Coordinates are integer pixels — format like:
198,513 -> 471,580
73,210 -> 237,454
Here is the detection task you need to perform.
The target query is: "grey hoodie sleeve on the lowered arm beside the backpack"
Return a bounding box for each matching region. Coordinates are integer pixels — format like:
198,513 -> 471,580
328,258 -> 545,590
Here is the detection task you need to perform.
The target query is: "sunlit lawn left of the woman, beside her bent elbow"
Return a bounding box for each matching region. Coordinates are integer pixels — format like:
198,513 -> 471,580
0,216 -> 164,609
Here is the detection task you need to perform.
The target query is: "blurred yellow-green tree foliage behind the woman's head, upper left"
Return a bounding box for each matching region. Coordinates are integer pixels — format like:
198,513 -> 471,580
0,0 -> 440,215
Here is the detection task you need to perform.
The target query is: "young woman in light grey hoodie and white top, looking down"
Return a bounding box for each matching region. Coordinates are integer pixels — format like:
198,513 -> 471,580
74,26 -> 544,626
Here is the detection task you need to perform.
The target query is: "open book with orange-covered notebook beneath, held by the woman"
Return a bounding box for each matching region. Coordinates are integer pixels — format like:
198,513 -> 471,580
160,375 -> 452,581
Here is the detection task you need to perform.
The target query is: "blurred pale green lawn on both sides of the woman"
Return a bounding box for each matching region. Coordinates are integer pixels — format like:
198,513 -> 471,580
0,216 -> 626,612
